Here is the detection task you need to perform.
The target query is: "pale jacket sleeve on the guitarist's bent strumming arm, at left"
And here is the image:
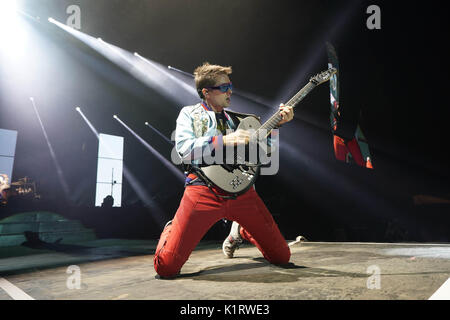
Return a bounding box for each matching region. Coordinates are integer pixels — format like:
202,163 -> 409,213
175,110 -> 223,164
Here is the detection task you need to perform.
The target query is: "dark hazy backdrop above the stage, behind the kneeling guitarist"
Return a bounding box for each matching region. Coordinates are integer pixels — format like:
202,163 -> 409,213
0,0 -> 450,241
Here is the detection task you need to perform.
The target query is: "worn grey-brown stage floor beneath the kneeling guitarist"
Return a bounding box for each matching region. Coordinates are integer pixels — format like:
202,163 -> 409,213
0,239 -> 450,300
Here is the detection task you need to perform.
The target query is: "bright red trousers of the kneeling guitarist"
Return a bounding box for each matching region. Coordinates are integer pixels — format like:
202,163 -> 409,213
153,186 -> 291,277
